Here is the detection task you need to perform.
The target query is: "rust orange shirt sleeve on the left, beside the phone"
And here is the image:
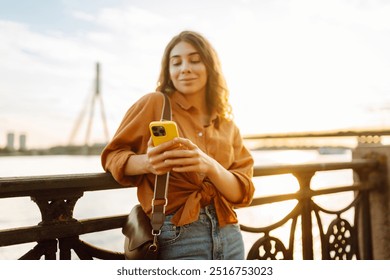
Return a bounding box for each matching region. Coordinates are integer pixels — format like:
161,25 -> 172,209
101,93 -> 163,186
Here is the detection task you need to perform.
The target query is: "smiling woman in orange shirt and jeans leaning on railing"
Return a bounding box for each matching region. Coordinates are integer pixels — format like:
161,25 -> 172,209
102,31 -> 254,260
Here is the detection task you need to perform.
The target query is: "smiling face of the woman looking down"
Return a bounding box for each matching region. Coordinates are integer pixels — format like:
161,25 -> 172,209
169,41 -> 207,97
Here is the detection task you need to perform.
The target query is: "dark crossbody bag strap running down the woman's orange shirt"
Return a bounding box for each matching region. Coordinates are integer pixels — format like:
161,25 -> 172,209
150,94 -> 172,234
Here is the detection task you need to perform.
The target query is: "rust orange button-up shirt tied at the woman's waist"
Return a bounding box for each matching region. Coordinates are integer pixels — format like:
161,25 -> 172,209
102,92 -> 254,227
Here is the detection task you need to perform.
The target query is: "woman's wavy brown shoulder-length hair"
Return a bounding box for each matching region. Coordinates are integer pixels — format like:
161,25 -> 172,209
156,31 -> 232,120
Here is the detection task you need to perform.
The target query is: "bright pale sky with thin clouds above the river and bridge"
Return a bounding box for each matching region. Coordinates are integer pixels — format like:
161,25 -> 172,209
0,0 -> 390,148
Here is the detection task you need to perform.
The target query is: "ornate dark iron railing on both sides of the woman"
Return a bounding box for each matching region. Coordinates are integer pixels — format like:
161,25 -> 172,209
0,156 -> 382,259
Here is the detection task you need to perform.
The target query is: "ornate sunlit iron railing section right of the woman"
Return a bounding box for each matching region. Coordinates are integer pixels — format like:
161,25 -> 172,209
241,160 -> 380,259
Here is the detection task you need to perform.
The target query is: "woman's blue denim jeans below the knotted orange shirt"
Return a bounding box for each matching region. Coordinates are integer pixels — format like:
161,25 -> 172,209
158,205 -> 245,260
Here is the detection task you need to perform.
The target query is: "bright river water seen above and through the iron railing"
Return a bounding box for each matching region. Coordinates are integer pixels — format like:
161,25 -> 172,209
0,150 -> 352,260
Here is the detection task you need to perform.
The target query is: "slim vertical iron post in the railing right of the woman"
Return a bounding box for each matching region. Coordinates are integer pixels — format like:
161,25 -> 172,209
293,172 -> 314,260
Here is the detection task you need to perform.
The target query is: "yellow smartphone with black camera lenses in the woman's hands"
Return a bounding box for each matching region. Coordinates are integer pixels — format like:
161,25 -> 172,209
149,121 -> 179,147
